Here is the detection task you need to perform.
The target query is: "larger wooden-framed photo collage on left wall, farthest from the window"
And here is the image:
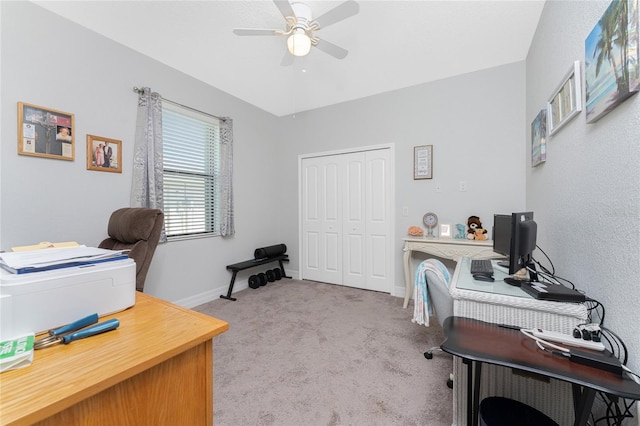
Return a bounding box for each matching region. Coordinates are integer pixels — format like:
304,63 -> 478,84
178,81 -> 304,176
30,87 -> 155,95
18,102 -> 75,161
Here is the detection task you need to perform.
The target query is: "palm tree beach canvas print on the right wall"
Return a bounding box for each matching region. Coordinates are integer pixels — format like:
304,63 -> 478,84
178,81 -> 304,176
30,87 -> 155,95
584,0 -> 640,123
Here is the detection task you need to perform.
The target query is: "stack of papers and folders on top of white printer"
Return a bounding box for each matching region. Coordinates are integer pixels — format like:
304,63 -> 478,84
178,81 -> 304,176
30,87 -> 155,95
0,245 -> 128,274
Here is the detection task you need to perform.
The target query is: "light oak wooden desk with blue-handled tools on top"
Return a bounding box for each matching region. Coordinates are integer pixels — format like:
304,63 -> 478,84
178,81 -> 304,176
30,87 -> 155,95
0,293 -> 229,426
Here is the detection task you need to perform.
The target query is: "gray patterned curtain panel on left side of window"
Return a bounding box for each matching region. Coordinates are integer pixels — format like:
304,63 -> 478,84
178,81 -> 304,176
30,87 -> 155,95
130,87 -> 167,242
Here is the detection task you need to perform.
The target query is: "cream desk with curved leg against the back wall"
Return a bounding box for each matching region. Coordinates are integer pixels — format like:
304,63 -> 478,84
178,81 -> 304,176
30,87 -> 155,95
402,237 -> 503,308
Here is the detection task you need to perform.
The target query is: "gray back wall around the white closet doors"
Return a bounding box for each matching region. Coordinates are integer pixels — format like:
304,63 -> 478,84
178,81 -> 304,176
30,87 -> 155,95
278,62 -> 526,295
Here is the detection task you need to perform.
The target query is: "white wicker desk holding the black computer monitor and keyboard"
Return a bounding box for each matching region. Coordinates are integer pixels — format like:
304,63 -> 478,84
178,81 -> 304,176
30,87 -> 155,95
449,258 -> 587,425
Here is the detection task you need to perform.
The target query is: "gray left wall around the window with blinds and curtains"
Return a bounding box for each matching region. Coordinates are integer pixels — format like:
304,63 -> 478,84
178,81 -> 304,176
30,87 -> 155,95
0,2 -> 288,305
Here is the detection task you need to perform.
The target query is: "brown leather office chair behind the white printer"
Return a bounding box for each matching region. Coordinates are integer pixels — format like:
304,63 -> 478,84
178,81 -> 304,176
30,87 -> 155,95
98,207 -> 164,291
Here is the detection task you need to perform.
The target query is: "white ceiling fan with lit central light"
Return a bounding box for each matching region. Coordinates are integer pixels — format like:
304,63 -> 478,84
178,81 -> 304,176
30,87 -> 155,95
233,0 -> 360,65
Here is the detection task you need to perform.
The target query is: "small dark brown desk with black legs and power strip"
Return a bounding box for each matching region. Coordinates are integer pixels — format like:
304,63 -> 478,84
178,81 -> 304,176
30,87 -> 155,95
441,317 -> 640,426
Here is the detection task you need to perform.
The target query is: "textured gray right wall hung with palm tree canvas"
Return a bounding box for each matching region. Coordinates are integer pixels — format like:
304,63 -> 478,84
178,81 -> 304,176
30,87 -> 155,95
526,1 -> 640,382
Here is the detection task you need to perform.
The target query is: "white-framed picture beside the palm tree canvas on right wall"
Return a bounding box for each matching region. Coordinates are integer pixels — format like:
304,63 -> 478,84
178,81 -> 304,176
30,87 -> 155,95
547,61 -> 582,135
